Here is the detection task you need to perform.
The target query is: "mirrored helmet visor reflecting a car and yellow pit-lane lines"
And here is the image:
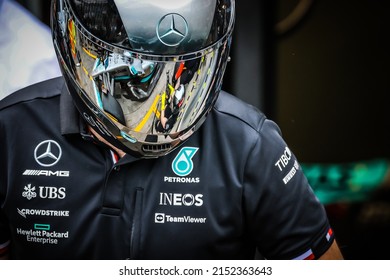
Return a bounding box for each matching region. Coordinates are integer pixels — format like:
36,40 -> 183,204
58,15 -> 226,142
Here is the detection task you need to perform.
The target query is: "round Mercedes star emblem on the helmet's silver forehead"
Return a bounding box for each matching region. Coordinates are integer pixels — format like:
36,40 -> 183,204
156,13 -> 188,47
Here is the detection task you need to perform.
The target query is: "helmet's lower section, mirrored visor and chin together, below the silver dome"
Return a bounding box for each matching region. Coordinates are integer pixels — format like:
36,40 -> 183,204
52,1 -> 235,158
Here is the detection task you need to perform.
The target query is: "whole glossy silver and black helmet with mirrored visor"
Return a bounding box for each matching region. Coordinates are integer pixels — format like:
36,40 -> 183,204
51,0 -> 235,158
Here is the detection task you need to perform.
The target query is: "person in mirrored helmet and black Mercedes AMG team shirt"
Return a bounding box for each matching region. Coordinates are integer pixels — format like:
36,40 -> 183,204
0,0 -> 343,259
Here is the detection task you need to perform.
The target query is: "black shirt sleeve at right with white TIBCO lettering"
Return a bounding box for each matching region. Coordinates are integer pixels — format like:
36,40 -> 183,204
244,120 -> 334,259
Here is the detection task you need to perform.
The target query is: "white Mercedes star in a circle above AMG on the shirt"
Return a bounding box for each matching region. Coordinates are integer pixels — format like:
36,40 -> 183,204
34,140 -> 62,167
